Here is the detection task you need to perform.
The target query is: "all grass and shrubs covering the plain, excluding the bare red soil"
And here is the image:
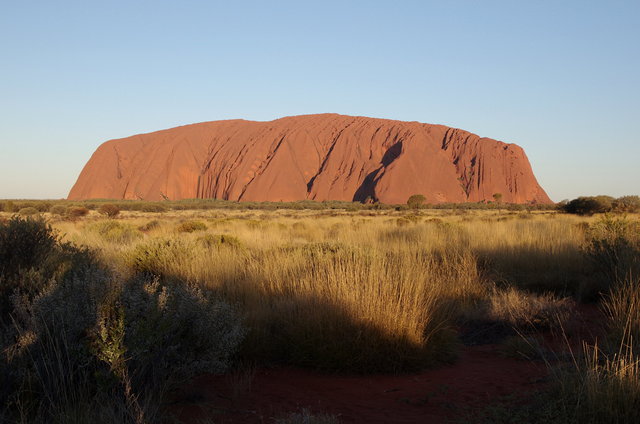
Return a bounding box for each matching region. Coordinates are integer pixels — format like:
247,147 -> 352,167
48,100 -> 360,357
0,201 -> 640,423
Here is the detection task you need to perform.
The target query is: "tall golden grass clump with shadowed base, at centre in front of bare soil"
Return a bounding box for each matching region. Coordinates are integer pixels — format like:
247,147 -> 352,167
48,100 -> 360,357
238,248 -> 472,372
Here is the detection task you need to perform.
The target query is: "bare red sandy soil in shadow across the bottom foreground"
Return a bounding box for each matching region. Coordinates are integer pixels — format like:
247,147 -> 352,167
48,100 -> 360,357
170,305 -> 604,424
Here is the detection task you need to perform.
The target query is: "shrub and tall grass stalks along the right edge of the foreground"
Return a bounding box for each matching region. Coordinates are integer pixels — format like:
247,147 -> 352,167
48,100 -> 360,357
536,216 -> 640,424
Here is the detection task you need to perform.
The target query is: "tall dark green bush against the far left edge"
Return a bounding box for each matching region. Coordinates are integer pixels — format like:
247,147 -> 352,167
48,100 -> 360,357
0,217 -> 98,422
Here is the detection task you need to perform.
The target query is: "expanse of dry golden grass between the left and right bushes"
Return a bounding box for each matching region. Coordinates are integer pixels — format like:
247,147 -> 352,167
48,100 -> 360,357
38,210 -> 600,371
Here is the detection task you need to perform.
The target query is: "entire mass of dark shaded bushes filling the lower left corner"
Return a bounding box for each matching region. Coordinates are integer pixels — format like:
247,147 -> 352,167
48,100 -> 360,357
0,218 -> 244,424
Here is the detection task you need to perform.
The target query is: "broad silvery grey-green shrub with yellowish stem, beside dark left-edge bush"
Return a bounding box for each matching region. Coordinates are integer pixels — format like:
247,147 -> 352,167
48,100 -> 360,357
0,267 -> 244,423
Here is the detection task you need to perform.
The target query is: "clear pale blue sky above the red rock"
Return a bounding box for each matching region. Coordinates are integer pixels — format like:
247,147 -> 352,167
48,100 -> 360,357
0,0 -> 640,201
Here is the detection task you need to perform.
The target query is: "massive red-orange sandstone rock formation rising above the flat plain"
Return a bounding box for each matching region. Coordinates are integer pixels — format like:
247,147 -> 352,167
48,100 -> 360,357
69,114 -> 551,203
